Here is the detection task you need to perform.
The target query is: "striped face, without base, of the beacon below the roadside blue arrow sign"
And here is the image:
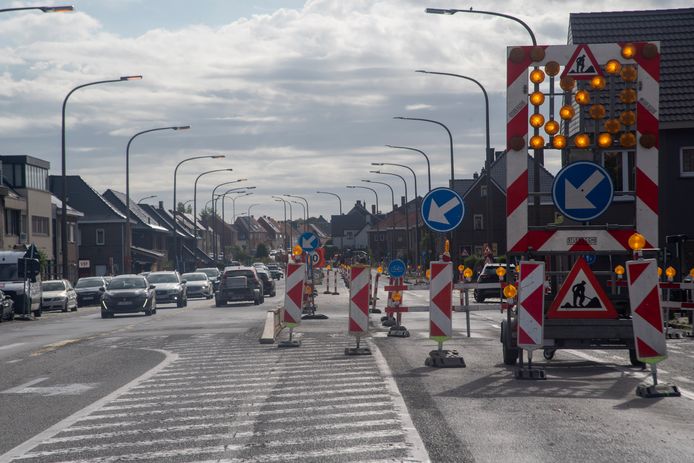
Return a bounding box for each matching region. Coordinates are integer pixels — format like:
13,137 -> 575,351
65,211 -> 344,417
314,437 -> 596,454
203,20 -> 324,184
429,262 -> 453,342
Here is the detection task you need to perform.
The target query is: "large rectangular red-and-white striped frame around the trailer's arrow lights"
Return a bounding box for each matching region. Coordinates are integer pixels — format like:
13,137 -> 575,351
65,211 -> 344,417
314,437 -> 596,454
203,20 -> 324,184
506,42 -> 660,252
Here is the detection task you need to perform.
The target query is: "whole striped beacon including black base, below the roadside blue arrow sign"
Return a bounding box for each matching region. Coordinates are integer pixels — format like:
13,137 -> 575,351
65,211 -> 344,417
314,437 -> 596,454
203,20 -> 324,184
424,261 -> 465,368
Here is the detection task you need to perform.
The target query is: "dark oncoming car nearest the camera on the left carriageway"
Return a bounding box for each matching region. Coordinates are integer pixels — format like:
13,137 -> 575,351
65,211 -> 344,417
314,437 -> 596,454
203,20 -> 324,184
101,275 -> 157,318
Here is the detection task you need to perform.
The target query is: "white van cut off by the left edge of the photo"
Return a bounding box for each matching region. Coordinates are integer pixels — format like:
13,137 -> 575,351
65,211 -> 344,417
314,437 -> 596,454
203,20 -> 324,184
0,245 -> 42,317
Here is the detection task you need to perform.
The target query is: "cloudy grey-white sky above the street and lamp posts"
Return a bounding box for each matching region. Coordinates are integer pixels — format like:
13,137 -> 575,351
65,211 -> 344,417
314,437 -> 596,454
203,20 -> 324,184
0,0 -> 691,218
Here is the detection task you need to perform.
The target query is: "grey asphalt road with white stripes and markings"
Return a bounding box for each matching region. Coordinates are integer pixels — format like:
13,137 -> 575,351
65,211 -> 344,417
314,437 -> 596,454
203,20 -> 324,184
0,274 -> 694,462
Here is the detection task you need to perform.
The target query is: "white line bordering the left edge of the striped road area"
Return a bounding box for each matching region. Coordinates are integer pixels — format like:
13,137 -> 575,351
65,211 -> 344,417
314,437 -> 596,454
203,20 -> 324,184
0,349 -> 178,461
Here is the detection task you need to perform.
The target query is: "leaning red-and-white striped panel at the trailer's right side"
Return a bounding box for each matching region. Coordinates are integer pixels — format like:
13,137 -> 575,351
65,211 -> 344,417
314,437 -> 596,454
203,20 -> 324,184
627,259 -> 667,363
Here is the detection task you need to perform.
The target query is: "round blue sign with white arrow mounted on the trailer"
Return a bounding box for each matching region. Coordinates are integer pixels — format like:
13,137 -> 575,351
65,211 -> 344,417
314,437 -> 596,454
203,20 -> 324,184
552,161 -> 614,222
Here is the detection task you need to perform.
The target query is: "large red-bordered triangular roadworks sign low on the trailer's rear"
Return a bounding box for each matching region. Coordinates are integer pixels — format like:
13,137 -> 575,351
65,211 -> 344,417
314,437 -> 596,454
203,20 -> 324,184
547,257 -> 618,319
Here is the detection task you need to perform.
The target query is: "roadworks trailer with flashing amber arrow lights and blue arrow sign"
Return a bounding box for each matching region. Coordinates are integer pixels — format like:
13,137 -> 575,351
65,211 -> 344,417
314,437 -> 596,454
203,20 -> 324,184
500,42 -> 660,365
